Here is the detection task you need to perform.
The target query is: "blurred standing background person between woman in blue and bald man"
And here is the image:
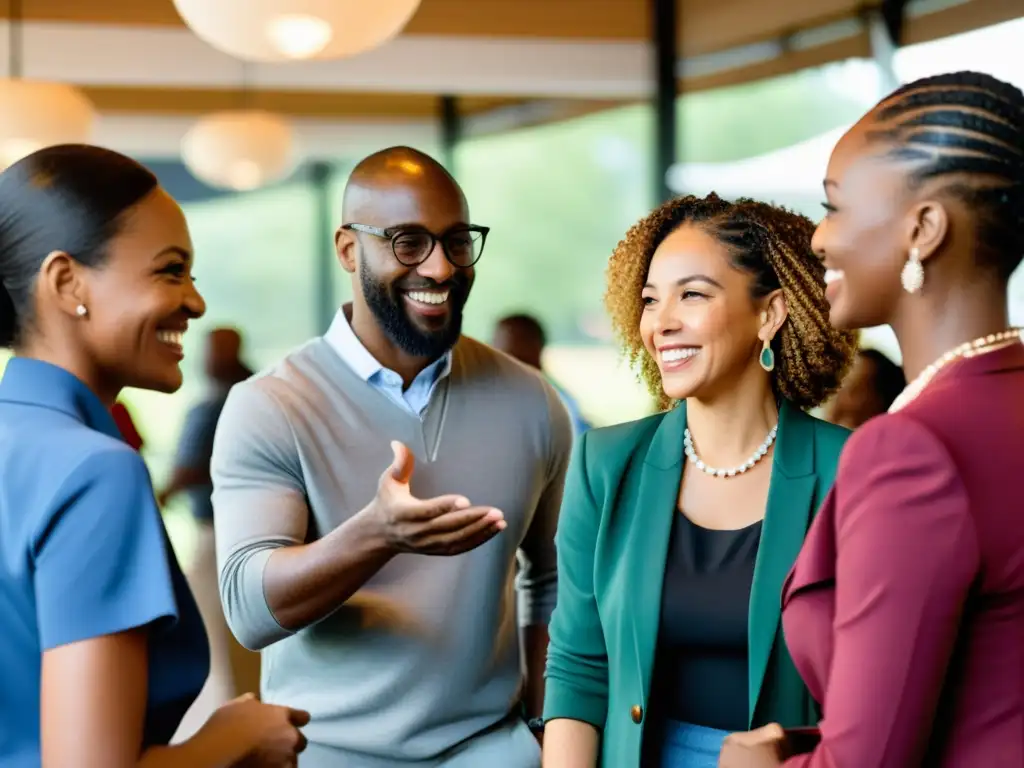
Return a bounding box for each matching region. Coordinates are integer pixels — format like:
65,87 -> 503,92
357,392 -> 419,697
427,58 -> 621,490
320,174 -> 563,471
158,328 -> 259,737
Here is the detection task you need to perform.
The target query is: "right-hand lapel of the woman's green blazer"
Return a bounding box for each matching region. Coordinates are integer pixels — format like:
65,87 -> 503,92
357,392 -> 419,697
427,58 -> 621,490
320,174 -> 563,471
748,400 -> 817,724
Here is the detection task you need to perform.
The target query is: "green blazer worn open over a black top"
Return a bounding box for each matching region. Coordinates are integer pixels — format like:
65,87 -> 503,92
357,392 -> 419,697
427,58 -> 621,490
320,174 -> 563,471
544,402 -> 850,768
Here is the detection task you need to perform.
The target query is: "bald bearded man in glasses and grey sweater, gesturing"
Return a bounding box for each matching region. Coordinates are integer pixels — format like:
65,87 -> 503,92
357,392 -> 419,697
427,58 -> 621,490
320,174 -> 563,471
213,147 -> 571,768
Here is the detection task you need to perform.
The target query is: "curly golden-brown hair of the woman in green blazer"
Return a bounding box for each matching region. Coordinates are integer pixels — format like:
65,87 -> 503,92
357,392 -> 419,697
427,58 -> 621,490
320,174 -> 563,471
604,193 -> 857,409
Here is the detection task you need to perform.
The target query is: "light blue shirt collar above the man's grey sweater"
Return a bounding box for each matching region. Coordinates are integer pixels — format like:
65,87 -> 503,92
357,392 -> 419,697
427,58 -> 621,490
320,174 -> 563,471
324,309 -> 452,416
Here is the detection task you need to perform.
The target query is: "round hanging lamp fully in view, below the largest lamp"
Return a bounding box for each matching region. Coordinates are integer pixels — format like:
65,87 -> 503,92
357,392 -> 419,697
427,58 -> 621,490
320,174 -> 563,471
181,110 -> 295,191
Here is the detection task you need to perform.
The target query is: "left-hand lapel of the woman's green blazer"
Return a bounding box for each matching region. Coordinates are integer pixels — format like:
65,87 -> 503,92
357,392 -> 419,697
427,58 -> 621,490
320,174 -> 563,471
623,403 -> 686,701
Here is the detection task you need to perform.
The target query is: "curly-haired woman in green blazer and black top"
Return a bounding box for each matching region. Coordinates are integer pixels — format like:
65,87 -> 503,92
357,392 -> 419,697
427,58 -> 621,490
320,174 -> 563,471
544,195 -> 856,768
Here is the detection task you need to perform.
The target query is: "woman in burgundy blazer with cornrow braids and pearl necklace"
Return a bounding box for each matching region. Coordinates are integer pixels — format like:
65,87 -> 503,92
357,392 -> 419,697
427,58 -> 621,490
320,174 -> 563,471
721,73 -> 1024,768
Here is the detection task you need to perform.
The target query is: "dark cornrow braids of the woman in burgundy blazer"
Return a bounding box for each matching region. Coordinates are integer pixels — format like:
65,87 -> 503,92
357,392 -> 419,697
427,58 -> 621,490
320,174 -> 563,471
869,72 -> 1024,280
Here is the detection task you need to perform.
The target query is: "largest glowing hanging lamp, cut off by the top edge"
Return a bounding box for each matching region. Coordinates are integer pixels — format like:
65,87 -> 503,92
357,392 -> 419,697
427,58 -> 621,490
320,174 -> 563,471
174,0 -> 420,61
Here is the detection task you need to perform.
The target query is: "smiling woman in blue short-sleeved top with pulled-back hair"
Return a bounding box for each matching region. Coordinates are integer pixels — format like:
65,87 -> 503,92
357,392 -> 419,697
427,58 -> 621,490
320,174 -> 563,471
0,145 -> 308,768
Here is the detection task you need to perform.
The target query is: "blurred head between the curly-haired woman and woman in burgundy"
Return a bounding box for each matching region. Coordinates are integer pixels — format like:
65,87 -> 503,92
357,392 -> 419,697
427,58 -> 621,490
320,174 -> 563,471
824,349 -> 906,429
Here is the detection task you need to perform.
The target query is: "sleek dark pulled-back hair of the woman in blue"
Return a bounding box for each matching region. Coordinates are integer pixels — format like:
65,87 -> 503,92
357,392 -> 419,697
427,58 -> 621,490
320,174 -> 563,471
0,144 -> 158,346
